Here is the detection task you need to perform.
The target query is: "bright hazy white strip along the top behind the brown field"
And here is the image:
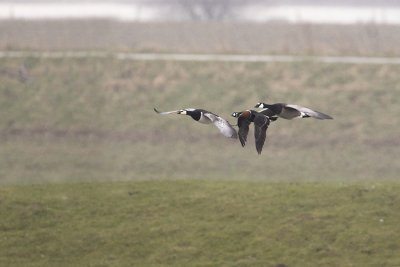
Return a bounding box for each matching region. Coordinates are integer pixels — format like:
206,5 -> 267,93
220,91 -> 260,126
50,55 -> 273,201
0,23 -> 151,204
0,0 -> 400,24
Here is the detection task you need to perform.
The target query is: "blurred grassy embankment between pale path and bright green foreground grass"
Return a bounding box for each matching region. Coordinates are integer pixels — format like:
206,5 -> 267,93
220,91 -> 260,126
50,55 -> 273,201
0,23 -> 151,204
0,58 -> 400,184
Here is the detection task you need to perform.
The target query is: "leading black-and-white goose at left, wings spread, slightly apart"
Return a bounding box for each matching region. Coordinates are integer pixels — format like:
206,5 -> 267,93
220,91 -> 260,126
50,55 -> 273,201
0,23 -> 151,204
154,108 -> 237,139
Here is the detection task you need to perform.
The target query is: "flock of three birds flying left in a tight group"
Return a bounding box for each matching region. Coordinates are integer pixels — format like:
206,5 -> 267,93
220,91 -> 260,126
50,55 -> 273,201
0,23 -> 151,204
154,103 -> 332,154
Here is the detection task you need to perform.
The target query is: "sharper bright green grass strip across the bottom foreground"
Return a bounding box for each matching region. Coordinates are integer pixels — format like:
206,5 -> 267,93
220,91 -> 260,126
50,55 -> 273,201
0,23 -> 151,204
0,180 -> 400,267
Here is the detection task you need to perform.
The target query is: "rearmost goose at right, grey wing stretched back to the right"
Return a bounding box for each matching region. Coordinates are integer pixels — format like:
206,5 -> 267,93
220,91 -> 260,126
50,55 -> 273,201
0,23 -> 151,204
254,103 -> 333,120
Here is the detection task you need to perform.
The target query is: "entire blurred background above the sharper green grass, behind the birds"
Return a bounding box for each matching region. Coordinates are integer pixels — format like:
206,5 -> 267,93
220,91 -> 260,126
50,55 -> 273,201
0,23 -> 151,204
0,0 -> 400,184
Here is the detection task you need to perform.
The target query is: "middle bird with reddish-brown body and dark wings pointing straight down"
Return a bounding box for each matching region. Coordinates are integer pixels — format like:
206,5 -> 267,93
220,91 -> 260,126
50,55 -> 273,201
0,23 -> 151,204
232,110 -> 277,154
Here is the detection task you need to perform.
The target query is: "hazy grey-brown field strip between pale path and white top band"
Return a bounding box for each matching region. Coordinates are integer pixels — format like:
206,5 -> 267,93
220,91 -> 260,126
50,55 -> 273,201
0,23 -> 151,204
0,20 -> 400,56
